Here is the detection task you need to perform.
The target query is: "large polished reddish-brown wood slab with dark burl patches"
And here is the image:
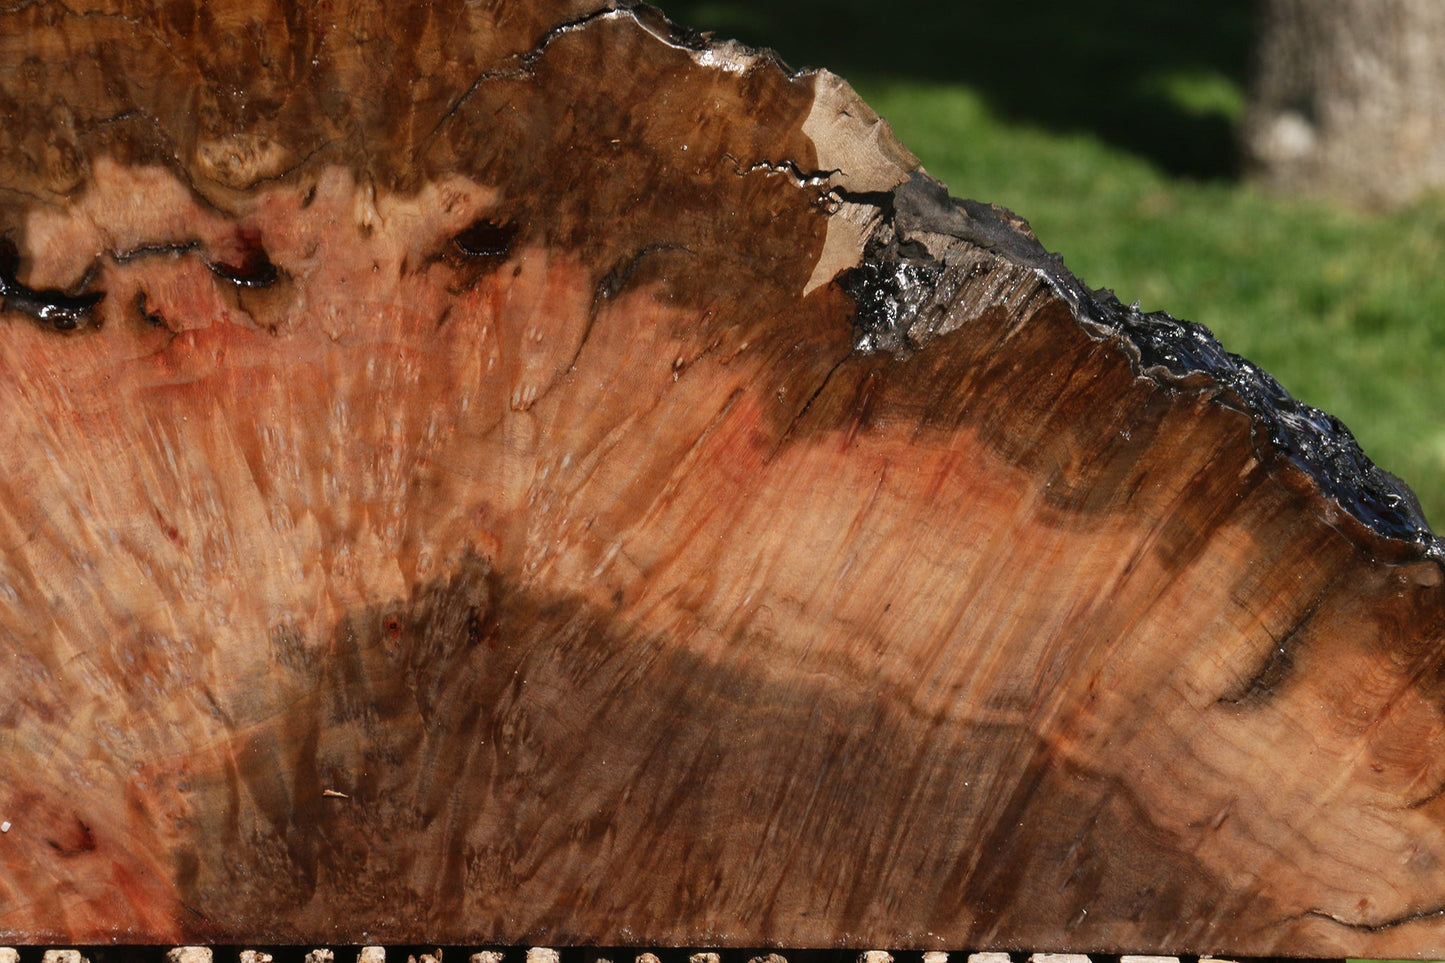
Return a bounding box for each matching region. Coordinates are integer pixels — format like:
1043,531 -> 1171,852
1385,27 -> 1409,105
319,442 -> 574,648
0,1 -> 1445,957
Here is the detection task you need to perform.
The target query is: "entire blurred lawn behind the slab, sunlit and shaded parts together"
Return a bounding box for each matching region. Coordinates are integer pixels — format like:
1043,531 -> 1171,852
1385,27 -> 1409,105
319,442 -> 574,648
665,0 -> 1445,531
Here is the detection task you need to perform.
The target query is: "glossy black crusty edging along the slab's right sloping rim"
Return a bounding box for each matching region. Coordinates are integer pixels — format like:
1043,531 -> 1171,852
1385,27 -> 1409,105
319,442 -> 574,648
840,172 -> 1445,562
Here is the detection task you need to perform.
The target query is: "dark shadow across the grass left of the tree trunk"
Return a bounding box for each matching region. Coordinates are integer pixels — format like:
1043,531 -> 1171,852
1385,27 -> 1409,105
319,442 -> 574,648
660,0 -> 1256,179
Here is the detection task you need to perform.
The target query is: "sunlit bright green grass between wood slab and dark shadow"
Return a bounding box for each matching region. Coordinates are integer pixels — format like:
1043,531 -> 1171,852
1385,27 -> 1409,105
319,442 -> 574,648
860,80 -> 1445,519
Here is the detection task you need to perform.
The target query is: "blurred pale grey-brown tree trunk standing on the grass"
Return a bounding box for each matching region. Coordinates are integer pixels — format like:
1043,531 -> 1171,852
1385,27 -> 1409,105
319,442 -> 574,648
1244,0 -> 1445,204
